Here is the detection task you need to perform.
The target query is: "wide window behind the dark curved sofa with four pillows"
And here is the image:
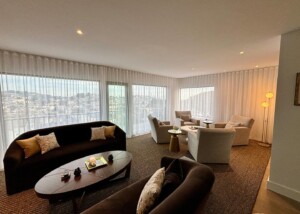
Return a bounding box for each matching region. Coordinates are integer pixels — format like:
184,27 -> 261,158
0,75 -> 100,145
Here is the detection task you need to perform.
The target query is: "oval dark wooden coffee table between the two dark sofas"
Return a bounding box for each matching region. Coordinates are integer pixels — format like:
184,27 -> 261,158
34,151 -> 132,212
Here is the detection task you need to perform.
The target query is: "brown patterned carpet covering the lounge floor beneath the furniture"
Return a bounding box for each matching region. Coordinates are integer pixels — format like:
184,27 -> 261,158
0,134 -> 270,214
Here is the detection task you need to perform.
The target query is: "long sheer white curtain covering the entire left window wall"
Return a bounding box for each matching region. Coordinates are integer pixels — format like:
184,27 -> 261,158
0,50 -> 177,169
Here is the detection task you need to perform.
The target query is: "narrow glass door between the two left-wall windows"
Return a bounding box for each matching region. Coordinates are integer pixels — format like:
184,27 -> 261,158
107,82 -> 128,132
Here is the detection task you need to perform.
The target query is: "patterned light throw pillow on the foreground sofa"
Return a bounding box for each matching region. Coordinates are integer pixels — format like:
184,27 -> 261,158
136,167 -> 165,214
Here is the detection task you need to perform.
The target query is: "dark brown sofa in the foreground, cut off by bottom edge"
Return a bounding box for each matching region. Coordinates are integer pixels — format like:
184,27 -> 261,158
83,157 -> 215,214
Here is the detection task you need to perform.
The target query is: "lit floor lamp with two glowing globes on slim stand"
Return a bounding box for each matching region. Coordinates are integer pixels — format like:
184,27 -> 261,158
259,92 -> 274,147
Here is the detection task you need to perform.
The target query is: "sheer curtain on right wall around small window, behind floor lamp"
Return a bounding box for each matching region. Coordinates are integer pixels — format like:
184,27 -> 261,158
178,66 -> 278,142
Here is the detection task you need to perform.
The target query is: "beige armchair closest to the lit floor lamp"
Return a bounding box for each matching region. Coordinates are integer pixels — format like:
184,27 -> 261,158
215,115 -> 254,146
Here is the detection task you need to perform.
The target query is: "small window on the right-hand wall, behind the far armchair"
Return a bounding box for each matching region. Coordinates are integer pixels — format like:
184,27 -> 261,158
180,87 -> 215,119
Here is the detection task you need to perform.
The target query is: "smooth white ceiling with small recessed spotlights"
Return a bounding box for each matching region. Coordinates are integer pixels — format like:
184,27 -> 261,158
0,0 -> 300,78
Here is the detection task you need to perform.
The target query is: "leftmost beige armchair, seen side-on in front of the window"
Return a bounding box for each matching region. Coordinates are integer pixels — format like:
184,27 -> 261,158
148,114 -> 173,143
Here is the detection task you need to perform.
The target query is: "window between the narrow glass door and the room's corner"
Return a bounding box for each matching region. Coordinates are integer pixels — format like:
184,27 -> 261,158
132,85 -> 167,135
